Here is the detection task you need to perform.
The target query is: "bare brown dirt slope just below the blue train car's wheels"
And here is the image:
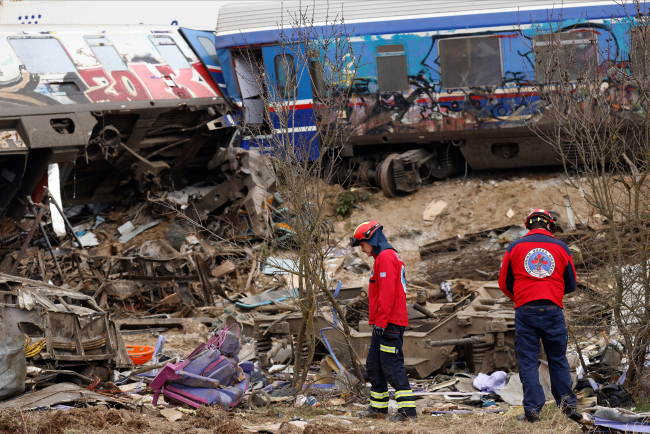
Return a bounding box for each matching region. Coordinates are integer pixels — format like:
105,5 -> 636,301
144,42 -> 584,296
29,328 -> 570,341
329,168 -> 595,278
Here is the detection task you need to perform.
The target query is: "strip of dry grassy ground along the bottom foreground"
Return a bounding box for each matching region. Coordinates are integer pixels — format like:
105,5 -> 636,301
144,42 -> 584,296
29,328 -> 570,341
0,406 -> 580,434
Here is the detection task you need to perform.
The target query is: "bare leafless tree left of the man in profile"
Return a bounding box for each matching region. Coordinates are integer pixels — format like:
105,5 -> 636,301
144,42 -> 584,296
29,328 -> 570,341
232,0 -> 362,387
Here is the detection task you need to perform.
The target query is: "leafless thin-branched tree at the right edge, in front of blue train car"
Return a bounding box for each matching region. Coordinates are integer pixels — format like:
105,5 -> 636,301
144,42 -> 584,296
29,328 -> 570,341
520,0 -> 650,394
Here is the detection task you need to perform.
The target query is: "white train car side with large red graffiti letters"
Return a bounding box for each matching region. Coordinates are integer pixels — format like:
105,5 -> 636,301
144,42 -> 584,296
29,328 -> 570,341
0,30 -> 220,106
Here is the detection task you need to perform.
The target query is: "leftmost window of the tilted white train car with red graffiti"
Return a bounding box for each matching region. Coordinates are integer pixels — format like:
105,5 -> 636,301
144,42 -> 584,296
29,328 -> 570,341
9,38 -> 77,74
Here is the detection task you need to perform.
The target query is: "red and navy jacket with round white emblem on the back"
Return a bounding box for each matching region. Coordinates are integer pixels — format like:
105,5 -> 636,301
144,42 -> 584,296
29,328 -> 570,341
499,229 -> 576,309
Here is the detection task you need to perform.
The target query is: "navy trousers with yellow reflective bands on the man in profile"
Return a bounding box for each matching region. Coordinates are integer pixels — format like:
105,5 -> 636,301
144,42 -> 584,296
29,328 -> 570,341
366,323 -> 417,417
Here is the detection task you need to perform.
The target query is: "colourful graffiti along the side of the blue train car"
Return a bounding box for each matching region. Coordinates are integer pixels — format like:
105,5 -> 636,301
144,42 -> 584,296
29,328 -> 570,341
336,18 -> 626,136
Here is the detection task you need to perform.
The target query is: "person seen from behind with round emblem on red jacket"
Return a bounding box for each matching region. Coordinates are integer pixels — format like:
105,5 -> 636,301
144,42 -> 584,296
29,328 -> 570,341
499,208 -> 577,422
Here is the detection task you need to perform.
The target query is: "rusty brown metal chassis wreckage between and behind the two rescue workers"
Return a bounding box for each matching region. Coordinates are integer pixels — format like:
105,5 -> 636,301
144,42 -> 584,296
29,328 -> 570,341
253,283 -> 517,378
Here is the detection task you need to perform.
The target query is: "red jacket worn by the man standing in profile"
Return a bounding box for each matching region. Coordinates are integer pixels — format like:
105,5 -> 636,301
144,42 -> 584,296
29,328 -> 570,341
368,249 -> 409,328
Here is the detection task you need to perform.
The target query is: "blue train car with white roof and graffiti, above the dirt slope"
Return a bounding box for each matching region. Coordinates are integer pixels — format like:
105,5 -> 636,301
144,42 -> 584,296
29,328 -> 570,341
209,0 -> 636,197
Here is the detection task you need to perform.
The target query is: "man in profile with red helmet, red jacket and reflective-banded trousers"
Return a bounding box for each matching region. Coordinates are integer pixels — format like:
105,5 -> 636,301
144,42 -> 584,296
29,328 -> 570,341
350,220 -> 417,421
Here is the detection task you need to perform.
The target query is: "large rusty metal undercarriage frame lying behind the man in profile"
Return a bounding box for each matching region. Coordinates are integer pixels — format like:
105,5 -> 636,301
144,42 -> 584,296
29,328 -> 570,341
253,283 -> 517,378
